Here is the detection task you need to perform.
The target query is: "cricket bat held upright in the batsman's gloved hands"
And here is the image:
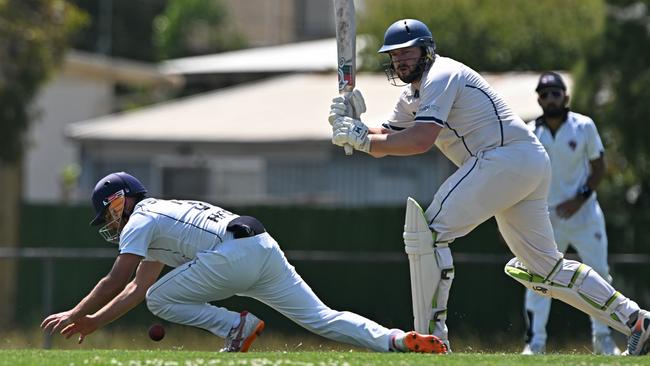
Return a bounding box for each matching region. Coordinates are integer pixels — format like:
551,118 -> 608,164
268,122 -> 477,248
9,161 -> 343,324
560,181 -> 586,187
334,0 -> 357,155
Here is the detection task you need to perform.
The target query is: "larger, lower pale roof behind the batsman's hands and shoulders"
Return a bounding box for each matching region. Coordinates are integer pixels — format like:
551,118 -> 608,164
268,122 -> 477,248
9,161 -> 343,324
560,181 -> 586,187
66,73 -> 571,142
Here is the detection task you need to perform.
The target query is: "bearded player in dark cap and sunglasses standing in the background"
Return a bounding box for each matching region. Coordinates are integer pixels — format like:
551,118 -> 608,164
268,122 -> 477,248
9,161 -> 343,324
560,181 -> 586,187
522,72 -> 620,355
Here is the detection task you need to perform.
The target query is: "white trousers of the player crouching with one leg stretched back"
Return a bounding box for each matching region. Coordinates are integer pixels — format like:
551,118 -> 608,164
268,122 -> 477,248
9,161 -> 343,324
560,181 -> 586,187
146,233 -> 402,352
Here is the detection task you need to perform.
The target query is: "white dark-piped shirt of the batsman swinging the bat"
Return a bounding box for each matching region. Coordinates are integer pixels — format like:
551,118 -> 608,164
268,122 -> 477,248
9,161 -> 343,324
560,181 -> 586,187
384,55 -> 536,166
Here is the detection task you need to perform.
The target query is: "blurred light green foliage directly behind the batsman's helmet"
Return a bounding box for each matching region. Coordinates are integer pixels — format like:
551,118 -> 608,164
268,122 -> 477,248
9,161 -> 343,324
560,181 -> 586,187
359,0 -> 605,71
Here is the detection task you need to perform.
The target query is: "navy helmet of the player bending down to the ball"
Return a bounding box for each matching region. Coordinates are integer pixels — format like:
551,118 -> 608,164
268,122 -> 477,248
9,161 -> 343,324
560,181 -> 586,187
90,172 -> 147,225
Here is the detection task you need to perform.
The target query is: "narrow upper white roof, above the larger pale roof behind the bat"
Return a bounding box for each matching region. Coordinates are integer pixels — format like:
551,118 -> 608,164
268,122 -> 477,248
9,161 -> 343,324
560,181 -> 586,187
161,37 -> 366,75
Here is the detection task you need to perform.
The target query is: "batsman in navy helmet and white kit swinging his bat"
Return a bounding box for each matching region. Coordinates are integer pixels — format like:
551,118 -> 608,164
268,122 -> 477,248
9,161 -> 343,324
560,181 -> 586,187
329,19 -> 650,355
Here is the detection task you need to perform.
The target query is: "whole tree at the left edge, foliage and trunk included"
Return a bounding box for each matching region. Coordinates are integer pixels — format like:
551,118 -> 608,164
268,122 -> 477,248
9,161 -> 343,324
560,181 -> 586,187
0,0 -> 85,321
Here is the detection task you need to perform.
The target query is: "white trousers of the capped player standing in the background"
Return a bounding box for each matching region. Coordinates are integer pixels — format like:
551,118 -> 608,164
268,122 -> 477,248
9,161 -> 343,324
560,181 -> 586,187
525,197 -> 611,345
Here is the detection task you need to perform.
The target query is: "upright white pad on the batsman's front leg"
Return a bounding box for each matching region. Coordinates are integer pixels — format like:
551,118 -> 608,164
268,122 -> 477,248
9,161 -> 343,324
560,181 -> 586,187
404,197 -> 454,340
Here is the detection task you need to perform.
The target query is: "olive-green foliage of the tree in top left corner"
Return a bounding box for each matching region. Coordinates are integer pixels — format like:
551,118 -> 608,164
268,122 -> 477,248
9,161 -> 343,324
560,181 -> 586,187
0,0 -> 86,162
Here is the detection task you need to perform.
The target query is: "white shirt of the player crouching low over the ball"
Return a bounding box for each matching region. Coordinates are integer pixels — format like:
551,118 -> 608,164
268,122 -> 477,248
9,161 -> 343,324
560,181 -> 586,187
119,198 -> 238,267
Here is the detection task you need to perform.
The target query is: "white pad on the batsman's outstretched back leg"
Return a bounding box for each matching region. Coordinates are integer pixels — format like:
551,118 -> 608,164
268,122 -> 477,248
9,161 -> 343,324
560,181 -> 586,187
505,258 -> 630,336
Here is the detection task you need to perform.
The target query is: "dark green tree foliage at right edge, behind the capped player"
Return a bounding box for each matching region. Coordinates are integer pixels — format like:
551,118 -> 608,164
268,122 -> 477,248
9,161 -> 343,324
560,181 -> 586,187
573,0 -> 650,252
